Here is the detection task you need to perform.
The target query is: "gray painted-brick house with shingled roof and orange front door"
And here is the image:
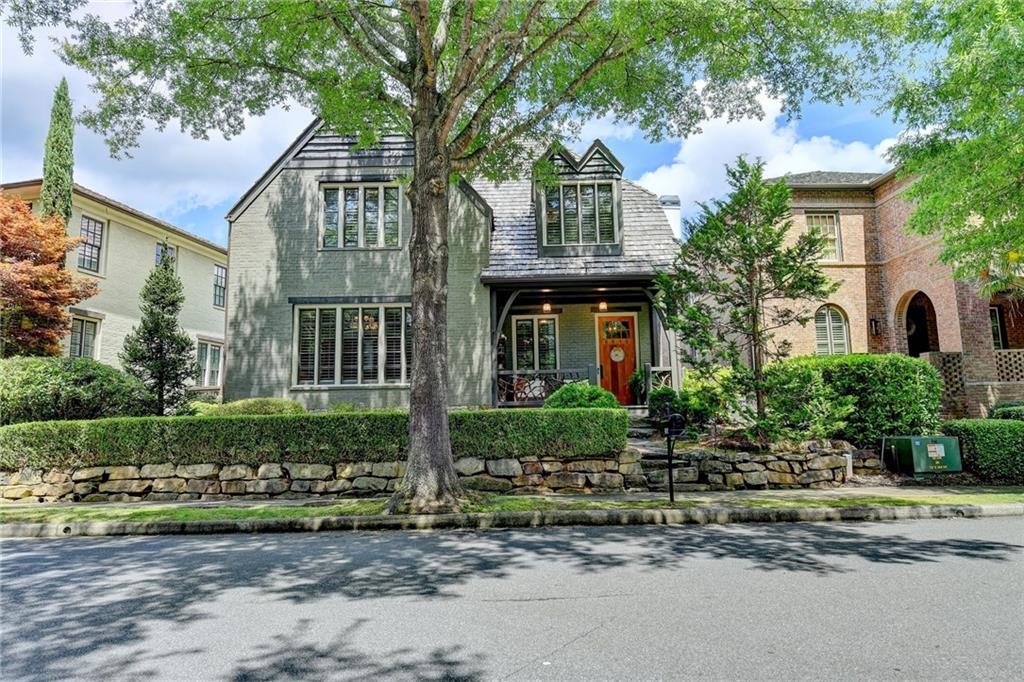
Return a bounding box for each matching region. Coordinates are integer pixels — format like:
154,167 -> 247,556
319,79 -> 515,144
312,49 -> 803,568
224,122 -> 679,409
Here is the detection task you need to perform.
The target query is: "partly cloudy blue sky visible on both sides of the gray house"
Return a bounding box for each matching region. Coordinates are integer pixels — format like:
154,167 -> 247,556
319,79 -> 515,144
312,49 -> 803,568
0,5 -> 898,244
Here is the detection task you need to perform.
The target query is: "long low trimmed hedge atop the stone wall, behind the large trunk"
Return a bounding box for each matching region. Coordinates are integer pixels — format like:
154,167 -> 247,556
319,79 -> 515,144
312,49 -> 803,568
0,410 -> 629,471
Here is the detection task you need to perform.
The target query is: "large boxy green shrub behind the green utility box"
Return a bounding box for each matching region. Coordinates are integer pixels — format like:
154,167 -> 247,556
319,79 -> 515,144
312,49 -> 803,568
773,353 -> 942,447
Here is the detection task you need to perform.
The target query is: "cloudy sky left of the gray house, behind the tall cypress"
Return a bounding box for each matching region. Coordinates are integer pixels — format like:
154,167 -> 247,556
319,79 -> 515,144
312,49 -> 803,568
0,13 -> 312,242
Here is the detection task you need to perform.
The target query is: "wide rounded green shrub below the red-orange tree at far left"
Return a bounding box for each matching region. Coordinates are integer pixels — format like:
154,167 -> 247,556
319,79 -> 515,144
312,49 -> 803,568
0,357 -> 153,424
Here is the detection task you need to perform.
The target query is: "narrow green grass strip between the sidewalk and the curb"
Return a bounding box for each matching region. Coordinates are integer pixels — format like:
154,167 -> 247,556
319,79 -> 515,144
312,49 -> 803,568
0,486 -> 1024,523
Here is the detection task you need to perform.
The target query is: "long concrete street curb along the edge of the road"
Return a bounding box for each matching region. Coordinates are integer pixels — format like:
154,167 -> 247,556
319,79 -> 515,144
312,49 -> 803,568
0,504 -> 1024,538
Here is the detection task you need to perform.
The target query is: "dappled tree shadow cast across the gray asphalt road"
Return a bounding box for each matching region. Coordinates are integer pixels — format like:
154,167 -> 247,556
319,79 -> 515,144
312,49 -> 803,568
0,521 -> 1024,679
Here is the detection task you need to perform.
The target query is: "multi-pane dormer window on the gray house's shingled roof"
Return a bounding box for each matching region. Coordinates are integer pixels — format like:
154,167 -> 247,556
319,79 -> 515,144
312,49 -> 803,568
544,182 -> 618,246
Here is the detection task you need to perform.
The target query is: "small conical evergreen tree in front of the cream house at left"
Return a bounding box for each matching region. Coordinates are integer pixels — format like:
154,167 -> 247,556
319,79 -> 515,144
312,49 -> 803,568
120,246 -> 199,415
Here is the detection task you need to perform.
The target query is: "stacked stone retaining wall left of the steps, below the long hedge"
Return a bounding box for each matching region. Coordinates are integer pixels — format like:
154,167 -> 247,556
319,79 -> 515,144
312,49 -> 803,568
0,449 -> 643,502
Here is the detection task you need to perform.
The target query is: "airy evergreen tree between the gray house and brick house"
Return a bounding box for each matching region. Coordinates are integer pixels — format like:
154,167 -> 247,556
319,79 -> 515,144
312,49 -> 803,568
657,158 -> 839,436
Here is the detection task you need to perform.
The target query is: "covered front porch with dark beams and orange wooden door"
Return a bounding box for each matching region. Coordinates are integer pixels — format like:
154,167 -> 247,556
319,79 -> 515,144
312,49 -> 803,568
490,281 -> 679,408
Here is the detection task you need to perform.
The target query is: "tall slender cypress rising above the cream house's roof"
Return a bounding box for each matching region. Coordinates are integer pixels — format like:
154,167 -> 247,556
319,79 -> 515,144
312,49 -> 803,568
39,78 -> 75,228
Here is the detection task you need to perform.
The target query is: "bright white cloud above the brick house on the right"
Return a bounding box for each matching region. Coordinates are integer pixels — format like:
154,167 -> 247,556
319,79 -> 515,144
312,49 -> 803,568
638,92 -> 895,233
